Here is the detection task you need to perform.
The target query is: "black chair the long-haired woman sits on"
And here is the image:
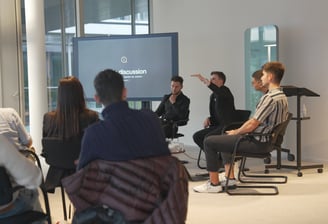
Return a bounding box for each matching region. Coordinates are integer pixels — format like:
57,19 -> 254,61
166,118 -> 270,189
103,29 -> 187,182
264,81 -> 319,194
41,137 -> 81,220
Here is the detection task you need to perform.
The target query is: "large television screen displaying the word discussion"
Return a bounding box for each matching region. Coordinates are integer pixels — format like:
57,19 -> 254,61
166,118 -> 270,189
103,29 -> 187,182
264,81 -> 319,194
73,33 -> 178,101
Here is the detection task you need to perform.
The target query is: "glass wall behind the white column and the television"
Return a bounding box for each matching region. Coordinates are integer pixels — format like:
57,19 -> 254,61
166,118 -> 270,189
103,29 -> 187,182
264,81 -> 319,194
21,0 -> 150,125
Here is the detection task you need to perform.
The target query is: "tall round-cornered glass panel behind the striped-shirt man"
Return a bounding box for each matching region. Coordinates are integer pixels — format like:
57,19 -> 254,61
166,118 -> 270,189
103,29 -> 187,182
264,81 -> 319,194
244,25 -> 278,114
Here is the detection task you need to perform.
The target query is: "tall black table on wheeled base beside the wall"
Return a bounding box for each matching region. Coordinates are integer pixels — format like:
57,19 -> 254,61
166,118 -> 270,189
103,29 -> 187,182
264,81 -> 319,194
265,86 -> 323,177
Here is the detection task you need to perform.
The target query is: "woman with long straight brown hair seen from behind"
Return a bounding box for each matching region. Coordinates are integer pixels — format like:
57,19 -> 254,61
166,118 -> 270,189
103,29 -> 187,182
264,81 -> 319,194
42,76 -> 99,192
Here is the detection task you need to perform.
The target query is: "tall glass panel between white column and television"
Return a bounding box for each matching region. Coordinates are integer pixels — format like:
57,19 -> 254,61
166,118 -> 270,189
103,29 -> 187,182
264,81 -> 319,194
45,0 -> 75,111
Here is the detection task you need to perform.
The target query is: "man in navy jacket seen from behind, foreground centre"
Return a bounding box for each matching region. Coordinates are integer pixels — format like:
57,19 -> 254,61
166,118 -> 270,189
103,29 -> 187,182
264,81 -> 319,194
78,69 -> 170,169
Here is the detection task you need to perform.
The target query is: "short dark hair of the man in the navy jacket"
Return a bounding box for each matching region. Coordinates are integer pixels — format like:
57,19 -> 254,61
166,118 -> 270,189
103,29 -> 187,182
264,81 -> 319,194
93,69 -> 124,106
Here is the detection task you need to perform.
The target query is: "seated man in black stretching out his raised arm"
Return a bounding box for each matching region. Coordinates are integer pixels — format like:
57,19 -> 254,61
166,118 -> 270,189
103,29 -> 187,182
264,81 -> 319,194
191,71 -> 236,165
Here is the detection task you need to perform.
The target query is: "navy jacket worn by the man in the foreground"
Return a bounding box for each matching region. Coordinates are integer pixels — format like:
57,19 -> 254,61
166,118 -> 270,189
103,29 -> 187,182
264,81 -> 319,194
78,101 -> 170,169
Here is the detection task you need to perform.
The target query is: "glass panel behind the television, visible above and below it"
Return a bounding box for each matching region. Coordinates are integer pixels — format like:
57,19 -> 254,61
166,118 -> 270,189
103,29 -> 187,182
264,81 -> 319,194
83,0 -> 149,111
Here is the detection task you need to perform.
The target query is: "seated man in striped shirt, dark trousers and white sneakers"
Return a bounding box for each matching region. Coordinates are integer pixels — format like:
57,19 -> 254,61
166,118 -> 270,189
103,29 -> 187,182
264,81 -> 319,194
193,62 -> 288,193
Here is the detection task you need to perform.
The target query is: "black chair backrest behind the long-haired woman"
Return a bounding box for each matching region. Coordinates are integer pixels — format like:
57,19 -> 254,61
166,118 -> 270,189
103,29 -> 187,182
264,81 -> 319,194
41,137 -> 81,169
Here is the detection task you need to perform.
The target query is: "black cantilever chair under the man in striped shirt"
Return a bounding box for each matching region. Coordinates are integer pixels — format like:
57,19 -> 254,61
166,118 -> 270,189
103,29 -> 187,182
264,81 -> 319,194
225,113 -> 292,195
